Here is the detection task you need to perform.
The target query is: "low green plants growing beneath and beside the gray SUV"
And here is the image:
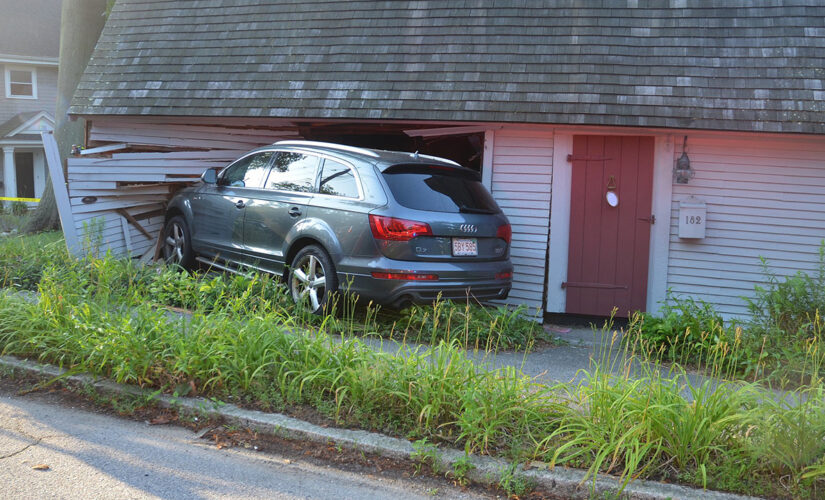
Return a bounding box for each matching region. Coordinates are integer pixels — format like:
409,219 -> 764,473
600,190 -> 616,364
0,233 -> 552,350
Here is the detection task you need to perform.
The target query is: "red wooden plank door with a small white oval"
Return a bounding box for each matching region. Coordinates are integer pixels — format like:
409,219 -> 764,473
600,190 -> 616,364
563,136 -> 652,317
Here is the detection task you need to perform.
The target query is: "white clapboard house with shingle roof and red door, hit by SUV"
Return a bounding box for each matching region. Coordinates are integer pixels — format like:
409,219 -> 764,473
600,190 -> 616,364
62,0 -> 825,316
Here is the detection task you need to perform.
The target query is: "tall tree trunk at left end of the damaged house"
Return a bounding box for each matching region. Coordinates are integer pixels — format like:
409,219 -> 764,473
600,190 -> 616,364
23,0 -> 108,233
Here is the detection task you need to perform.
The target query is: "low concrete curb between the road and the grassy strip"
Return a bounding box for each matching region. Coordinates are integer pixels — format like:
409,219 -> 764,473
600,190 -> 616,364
0,356 -> 755,500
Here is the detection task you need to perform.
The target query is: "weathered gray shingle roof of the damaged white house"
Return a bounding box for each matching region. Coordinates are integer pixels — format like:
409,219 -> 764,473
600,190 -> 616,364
70,0 -> 825,134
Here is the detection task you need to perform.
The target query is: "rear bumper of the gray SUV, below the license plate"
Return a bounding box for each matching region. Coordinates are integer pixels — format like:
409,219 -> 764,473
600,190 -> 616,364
339,258 -> 513,307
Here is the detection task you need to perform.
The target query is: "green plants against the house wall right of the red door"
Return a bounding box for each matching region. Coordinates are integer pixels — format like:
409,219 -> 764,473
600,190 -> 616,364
624,244 -> 825,387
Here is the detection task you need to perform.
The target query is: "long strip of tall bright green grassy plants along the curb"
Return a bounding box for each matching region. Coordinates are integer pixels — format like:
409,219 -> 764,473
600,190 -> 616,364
0,232 -> 825,498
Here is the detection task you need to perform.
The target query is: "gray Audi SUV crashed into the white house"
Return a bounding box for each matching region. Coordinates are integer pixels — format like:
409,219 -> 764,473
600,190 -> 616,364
162,141 -> 513,312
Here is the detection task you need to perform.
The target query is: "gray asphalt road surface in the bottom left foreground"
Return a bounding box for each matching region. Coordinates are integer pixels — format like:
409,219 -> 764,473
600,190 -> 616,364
0,387 -> 489,499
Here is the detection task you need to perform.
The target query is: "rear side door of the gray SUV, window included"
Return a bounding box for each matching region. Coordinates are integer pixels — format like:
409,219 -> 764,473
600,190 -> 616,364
243,151 -> 320,272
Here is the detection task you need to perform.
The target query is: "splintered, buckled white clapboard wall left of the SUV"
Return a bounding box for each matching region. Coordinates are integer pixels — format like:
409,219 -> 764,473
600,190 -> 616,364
67,117 -> 300,257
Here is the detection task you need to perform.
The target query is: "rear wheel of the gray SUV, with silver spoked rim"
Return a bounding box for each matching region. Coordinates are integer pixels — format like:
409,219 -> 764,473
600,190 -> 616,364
289,245 -> 338,314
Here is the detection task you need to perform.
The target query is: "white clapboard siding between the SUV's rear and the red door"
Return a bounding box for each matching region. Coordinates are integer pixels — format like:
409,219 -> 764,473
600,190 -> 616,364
491,129 -> 553,311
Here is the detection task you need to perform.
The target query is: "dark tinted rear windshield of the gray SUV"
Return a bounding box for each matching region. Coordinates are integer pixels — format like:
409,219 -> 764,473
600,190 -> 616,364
383,165 -> 500,214
